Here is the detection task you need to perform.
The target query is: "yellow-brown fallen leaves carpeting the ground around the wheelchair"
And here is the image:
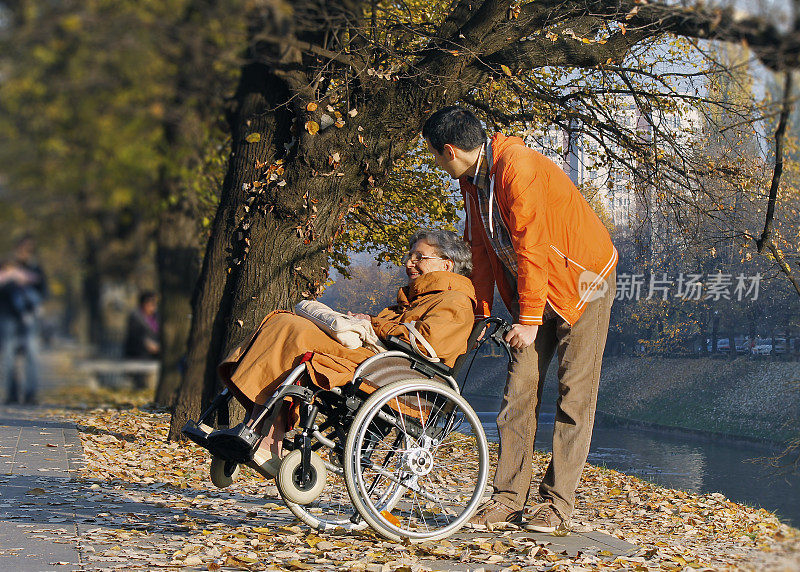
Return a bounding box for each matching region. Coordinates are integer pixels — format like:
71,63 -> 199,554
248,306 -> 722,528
17,386 -> 800,572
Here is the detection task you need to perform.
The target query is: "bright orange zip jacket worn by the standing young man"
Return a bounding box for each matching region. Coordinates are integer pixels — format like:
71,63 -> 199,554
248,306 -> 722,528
459,134 -> 617,325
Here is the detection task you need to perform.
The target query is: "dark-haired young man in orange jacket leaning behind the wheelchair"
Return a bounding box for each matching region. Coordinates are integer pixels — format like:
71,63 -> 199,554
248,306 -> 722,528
422,107 -> 617,532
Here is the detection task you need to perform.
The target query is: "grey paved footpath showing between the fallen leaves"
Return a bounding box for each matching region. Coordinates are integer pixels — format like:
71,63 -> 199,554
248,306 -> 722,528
0,342 -> 638,572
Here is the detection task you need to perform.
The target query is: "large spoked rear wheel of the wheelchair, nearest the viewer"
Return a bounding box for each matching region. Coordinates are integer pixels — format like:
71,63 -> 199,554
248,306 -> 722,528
344,379 -> 489,542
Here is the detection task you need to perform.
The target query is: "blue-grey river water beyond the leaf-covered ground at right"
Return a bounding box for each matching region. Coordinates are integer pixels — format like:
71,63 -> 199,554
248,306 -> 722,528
478,411 -> 800,527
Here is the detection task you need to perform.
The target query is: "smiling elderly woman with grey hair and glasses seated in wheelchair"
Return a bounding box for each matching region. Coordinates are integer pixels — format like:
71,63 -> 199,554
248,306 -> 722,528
214,230 -> 475,474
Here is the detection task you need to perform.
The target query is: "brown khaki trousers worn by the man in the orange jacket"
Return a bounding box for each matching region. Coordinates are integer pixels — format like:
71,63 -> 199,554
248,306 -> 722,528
493,272 -> 616,518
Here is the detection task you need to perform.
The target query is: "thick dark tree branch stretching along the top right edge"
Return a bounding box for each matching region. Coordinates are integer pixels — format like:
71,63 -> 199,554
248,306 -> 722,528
444,0 -> 800,80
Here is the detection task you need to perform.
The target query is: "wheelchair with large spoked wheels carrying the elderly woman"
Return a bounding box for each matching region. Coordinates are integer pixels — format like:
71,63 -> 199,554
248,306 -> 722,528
183,318 -> 511,542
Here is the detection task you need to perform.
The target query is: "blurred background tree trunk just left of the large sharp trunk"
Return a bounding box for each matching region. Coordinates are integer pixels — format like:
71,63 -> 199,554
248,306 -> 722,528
155,0 -> 247,406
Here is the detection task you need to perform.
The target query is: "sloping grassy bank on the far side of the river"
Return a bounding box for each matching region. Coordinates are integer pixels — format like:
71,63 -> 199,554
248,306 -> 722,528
465,356 -> 800,447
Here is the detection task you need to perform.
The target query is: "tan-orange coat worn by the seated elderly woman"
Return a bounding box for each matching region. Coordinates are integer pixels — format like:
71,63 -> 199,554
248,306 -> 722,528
218,272 -> 475,409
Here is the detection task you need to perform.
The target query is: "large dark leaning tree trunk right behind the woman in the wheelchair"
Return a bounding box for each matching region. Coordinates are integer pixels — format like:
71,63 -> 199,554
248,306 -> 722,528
170,45 -> 459,438
